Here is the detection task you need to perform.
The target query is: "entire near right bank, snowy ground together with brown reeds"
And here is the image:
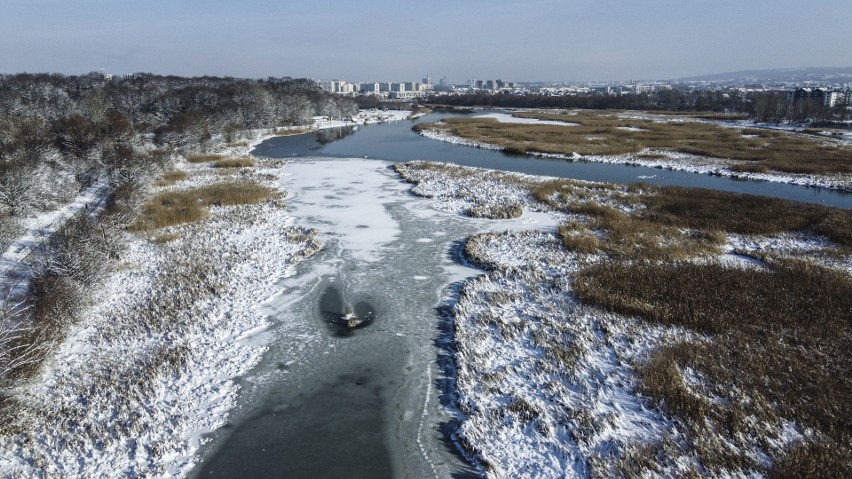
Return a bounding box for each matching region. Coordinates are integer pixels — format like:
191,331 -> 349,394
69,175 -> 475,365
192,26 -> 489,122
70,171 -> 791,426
396,162 -> 852,477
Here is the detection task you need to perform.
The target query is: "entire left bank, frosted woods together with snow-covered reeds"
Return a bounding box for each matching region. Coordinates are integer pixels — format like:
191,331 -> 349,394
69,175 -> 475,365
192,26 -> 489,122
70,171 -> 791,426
0,74 -> 356,477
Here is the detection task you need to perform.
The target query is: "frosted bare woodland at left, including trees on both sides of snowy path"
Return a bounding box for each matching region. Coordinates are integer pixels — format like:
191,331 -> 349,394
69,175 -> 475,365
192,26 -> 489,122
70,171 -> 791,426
0,73 -> 358,390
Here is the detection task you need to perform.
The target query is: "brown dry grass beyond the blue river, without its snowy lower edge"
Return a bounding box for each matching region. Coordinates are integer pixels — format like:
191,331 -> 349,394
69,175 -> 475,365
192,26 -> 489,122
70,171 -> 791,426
416,111 -> 852,175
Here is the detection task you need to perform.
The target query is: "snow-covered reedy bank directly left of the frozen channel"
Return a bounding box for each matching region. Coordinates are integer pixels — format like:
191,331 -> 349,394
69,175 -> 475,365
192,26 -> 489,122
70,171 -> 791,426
0,157 -> 320,477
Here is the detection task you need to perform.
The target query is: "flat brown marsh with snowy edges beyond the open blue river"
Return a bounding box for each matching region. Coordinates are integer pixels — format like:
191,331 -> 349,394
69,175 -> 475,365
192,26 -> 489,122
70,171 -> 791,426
415,110 -> 852,190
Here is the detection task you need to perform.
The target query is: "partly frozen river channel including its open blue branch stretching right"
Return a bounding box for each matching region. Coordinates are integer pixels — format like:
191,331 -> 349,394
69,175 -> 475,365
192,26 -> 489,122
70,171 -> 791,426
192,115 -> 852,478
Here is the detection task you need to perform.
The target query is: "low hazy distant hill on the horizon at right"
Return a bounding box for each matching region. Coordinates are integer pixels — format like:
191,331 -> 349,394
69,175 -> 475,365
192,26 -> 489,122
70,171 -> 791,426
673,67 -> 852,84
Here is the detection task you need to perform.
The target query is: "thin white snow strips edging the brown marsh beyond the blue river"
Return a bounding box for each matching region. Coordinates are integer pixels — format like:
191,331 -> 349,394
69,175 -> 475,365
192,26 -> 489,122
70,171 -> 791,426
419,113 -> 852,191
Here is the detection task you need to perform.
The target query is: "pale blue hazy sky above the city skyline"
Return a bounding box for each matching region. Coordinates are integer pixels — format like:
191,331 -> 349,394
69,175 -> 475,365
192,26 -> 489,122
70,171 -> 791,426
0,0 -> 852,82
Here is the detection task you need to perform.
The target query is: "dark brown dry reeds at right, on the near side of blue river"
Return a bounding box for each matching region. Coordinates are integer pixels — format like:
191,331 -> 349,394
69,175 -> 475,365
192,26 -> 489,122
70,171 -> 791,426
537,169 -> 852,476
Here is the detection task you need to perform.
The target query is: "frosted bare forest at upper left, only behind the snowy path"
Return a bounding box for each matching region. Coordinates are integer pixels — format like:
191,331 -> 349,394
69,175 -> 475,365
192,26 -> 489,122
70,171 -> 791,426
0,73 -> 357,246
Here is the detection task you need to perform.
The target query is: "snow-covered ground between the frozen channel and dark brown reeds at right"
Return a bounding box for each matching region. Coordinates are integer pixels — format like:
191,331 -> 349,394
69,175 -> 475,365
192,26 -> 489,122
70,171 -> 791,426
452,232 -> 678,477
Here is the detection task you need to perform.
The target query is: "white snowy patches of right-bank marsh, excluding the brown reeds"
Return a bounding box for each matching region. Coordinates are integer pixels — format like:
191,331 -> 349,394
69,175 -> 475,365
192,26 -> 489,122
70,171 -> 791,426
396,162 -> 852,477
